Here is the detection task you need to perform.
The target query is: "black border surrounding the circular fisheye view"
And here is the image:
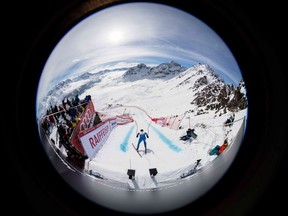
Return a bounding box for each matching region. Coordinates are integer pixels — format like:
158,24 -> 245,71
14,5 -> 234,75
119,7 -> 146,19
6,0 -> 287,215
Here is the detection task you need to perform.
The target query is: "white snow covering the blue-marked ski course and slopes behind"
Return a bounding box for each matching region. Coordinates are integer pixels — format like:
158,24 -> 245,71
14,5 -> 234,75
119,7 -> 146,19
42,63 -> 247,189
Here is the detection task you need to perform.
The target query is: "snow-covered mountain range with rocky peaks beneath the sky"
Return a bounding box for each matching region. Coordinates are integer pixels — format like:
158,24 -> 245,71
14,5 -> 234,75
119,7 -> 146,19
38,61 -> 248,120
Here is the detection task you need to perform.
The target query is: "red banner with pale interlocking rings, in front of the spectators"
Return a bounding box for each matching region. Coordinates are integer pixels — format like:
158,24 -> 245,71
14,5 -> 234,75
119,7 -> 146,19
70,101 -> 95,155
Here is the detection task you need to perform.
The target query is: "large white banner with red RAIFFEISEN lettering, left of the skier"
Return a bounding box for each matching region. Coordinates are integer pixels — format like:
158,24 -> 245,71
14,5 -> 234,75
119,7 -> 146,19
78,119 -> 116,159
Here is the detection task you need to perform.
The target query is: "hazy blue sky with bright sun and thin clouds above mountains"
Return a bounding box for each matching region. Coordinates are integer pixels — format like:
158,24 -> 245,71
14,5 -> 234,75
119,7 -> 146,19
37,3 -> 242,102
